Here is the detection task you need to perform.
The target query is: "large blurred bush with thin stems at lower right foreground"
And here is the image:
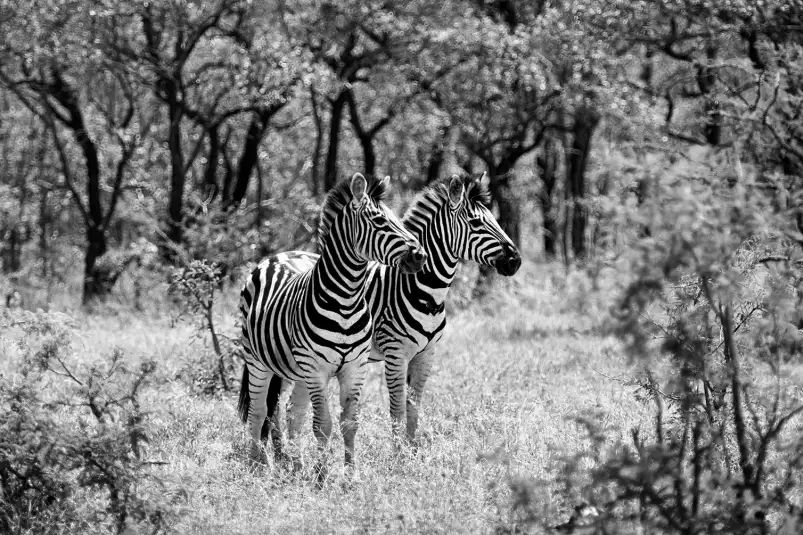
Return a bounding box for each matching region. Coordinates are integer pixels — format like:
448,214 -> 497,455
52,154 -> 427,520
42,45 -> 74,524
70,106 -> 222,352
496,165 -> 803,534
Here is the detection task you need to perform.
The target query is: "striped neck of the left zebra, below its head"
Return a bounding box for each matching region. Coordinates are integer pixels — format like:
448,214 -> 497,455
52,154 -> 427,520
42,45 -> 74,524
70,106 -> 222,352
309,240 -> 368,315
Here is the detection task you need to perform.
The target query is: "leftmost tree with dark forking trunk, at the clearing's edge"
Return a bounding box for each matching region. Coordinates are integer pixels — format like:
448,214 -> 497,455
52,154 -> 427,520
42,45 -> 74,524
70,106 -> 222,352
0,0 -> 150,303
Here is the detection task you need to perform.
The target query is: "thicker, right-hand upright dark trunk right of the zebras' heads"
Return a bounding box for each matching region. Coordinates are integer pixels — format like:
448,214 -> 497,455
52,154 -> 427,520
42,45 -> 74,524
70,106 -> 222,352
566,106 -> 600,260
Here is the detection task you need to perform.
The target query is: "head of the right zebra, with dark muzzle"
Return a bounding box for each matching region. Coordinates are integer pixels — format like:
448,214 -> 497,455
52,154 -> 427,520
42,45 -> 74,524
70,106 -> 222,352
447,173 -> 521,277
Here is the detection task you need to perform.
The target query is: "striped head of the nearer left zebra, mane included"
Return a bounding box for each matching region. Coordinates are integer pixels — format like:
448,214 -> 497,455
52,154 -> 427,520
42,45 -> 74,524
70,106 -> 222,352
319,173 -> 427,273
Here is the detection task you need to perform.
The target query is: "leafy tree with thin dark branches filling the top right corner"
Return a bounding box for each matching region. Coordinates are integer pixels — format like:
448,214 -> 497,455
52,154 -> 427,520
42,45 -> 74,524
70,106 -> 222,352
586,0 -> 803,234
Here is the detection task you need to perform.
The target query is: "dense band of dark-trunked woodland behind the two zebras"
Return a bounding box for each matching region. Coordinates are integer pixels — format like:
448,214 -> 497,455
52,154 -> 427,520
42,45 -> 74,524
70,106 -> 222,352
0,0 -> 803,302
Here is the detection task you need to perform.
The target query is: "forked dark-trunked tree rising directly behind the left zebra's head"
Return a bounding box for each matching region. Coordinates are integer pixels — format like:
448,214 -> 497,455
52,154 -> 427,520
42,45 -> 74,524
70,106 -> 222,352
284,1 -> 448,191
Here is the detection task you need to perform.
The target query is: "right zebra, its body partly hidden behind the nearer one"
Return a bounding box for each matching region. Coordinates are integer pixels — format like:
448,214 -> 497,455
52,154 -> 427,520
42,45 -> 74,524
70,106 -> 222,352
282,175 -> 521,440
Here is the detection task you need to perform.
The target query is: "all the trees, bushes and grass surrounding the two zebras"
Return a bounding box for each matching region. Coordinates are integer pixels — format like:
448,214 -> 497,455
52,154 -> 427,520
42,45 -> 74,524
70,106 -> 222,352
0,0 -> 803,534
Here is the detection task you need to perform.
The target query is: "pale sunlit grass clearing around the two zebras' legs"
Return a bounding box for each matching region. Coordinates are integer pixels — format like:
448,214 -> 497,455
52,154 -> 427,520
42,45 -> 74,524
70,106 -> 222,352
0,263 -> 660,534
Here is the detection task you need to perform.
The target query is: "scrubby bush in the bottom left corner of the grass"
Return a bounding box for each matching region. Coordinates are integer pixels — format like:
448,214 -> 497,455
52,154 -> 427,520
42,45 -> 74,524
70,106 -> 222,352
0,313 -> 174,533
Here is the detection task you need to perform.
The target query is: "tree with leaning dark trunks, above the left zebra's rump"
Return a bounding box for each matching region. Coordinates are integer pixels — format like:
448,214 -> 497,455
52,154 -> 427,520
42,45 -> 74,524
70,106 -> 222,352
177,5 -> 310,209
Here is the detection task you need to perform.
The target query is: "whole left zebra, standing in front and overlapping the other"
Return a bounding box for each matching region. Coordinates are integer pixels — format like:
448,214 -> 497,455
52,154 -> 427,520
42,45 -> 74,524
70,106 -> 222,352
238,173 -> 426,479
